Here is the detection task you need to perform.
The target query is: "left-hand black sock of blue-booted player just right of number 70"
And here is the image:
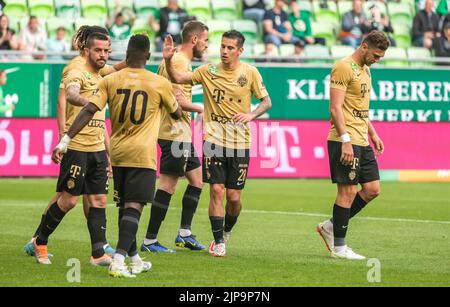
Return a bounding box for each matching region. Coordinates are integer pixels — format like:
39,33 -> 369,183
145,190 -> 172,240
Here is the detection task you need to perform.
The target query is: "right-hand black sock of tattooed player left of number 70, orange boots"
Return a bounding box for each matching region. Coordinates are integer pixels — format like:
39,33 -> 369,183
87,207 -> 106,258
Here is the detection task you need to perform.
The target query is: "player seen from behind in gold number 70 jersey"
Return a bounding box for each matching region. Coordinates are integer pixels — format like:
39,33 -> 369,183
53,35 -> 182,277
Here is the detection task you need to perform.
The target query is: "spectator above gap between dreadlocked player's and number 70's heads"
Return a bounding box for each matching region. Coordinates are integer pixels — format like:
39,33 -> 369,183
106,1 -> 136,40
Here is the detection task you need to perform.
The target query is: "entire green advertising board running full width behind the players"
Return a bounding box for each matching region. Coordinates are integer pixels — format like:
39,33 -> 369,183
0,63 -> 450,122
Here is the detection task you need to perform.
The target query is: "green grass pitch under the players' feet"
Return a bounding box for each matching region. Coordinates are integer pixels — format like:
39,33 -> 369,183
0,179 -> 450,287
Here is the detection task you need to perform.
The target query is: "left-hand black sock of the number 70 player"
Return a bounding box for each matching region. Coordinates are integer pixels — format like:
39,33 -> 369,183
116,208 -> 141,257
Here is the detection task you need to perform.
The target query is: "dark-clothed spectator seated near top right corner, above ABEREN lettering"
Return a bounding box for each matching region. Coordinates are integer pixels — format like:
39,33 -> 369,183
412,0 -> 440,49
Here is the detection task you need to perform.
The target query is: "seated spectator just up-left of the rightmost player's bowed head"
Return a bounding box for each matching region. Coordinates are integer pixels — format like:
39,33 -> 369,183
339,0 -> 371,48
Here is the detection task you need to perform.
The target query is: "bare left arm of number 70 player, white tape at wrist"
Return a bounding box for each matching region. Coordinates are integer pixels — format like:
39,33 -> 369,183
52,103 -> 99,164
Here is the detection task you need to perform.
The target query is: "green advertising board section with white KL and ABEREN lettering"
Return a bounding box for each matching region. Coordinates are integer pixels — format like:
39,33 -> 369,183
259,67 -> 450,122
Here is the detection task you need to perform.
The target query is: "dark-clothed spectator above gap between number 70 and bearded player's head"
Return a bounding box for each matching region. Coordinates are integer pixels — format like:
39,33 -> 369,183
150,0 -> 190,51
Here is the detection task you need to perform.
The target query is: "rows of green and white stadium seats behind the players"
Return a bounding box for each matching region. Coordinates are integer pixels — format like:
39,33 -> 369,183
3,0 -> 446,67
